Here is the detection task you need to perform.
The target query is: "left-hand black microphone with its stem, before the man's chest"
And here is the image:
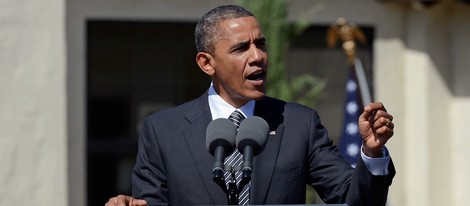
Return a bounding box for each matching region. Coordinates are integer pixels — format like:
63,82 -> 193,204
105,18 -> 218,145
206,118 -> 237,180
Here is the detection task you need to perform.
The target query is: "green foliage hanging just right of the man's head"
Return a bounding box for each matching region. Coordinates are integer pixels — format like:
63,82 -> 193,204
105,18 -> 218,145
239,0 -> 326,107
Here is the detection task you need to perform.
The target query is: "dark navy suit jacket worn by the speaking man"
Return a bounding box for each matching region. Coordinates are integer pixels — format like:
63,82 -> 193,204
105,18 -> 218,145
132,92 -> 395,206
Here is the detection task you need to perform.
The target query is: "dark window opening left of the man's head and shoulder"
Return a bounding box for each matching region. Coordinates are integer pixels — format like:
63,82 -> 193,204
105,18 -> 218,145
86,20 -> 210,206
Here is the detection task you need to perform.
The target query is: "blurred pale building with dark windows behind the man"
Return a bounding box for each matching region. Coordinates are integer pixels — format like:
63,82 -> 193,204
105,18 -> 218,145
0,0 -> 470,206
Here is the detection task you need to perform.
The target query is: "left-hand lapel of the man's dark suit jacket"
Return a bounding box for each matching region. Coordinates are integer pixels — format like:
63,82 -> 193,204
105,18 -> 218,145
183,92 -> 227,204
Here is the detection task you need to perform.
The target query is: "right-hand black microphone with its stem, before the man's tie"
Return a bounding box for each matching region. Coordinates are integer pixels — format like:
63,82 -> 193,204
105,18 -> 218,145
236,116 -> 269,180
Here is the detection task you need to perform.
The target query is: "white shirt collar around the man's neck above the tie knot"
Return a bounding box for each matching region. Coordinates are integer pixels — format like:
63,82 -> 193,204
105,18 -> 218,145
208,84 -> 255,120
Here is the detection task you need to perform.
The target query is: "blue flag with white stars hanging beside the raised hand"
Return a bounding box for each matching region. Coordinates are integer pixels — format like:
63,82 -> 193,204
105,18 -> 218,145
339,69 -> 363,167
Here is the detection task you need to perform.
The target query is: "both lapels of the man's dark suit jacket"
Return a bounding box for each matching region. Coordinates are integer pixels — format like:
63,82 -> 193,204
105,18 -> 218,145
183,92 -> 285,204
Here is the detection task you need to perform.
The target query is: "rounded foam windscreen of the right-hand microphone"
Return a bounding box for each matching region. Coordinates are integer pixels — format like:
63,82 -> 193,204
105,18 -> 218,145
236,116 -> 269,154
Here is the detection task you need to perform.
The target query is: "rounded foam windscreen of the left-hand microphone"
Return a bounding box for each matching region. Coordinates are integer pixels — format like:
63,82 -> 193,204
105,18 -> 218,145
206,118 -> 237,157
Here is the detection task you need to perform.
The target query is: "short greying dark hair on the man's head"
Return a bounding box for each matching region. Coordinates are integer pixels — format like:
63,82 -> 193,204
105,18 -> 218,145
194,5 -> 254,54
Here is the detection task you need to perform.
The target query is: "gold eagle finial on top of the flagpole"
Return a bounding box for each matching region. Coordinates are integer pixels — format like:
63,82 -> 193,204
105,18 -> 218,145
327,17 -> 367,63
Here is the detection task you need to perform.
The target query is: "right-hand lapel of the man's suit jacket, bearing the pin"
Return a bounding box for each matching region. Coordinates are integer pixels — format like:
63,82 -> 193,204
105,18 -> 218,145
250,97 -> 284,204
